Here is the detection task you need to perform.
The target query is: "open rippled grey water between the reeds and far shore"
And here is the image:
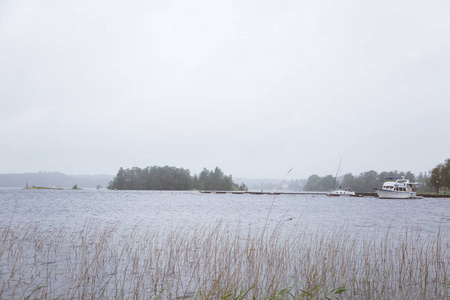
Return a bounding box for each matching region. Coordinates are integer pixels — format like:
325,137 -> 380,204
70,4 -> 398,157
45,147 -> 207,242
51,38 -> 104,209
0,188 -> 450,233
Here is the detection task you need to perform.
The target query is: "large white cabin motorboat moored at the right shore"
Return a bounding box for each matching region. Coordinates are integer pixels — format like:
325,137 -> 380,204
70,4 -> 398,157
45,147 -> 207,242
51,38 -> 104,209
377,177 -> 422,199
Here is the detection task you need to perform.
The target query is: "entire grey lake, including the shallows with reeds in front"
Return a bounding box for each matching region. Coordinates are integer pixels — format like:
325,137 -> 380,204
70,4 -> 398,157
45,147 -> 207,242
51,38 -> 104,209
0,188 -> 450,299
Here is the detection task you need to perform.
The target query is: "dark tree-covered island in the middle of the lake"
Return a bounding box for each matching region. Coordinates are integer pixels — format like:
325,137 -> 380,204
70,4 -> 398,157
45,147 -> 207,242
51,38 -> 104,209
107,166 -> 247,191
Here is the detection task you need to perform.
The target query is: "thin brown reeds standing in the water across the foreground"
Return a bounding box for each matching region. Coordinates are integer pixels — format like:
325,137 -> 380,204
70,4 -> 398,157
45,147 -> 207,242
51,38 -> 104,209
0,223 -> 450,299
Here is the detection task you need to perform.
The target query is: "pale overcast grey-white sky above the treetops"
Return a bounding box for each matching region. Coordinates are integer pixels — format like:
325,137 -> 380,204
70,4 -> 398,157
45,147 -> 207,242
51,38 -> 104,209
0,0 -> 450,179
